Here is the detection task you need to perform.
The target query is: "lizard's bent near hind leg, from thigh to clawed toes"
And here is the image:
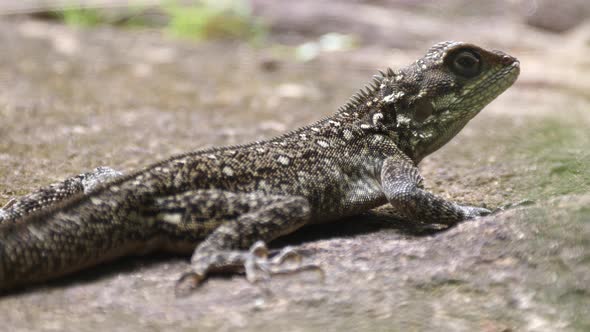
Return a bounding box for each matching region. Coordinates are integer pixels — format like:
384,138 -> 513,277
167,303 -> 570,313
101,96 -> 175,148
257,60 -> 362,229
143,190 -> 319,295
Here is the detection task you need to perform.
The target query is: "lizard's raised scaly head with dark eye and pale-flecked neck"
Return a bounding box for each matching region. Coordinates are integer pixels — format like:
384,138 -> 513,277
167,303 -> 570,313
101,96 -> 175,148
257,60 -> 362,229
378,42 -> 520,163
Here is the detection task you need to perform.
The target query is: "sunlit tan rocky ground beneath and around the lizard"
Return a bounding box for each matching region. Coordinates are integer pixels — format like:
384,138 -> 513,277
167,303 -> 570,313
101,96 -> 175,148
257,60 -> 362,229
0,1 -> 590,331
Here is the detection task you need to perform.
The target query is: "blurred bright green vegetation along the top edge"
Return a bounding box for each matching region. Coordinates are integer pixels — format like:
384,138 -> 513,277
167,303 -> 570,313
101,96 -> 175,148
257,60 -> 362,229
50,0 -> 267,44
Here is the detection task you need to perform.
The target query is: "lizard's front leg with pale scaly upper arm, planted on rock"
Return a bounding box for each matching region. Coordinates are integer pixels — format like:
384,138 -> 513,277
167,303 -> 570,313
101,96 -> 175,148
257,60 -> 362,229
381,158 -> 491,225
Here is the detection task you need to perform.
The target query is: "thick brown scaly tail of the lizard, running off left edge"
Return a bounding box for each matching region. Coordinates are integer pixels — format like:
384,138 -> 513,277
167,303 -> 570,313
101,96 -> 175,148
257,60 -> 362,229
0,195 -> 155,291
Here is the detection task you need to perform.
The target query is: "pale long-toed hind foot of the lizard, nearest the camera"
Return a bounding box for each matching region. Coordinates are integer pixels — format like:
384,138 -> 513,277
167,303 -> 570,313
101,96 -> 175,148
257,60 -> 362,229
175,241 -> 324,297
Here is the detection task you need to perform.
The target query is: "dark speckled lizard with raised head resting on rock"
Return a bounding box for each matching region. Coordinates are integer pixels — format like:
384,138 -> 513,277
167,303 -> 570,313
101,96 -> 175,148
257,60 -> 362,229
0,41 -> 520,294
